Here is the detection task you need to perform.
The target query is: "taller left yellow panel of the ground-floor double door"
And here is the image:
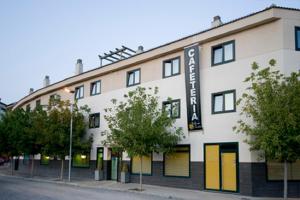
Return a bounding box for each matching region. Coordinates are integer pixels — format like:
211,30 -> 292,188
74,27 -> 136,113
205,145 -> 220,190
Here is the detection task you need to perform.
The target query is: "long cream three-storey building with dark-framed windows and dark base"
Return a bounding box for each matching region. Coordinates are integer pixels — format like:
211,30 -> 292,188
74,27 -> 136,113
14,6 -> 300,197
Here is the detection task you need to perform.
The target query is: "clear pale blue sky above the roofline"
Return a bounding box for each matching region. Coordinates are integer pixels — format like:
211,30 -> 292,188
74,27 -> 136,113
0,0 -> 300,104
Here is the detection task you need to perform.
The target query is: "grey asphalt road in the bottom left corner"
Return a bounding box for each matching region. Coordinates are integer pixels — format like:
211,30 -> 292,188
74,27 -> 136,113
0,176 -> 170,200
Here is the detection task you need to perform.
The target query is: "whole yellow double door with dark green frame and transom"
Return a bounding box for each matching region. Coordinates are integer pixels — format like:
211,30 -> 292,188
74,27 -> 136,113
204,143 -> 238,192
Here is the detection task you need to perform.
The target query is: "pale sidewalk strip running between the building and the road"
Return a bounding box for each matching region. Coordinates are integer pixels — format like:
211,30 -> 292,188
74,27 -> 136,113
0,165 -> 296,200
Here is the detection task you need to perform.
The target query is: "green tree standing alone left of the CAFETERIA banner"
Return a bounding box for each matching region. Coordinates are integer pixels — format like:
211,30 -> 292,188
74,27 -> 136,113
103,87 -> 182,190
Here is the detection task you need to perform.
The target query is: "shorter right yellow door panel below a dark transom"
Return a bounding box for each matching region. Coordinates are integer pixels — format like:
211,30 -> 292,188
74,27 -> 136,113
221,153 -> 237,191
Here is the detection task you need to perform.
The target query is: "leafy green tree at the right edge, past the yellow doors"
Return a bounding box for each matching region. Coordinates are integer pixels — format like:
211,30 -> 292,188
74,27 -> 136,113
234,59 -> 300,199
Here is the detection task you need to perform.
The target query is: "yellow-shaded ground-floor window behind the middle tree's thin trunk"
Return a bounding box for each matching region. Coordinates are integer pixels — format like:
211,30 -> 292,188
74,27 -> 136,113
131,155 -> 152,175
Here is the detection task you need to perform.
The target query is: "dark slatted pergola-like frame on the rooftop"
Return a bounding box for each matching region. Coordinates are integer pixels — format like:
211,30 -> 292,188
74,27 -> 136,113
98,46 -> 136,67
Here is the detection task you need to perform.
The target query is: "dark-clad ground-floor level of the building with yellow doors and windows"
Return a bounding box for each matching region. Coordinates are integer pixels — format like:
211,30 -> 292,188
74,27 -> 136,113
15,142 -> 300,197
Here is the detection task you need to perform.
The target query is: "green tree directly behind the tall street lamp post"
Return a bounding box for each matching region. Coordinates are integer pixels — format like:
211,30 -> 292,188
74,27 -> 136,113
42,99 -> 92,179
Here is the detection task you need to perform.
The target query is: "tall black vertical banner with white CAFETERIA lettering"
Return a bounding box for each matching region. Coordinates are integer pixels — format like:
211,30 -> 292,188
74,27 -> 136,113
184,44 -> 202,130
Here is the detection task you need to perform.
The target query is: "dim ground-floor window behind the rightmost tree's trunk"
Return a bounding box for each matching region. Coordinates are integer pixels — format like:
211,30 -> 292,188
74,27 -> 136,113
267,160 -> 300,181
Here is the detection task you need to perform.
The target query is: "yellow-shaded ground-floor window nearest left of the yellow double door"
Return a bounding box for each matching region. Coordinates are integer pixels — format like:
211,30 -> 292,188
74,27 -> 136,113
164,145 -> 190,177
